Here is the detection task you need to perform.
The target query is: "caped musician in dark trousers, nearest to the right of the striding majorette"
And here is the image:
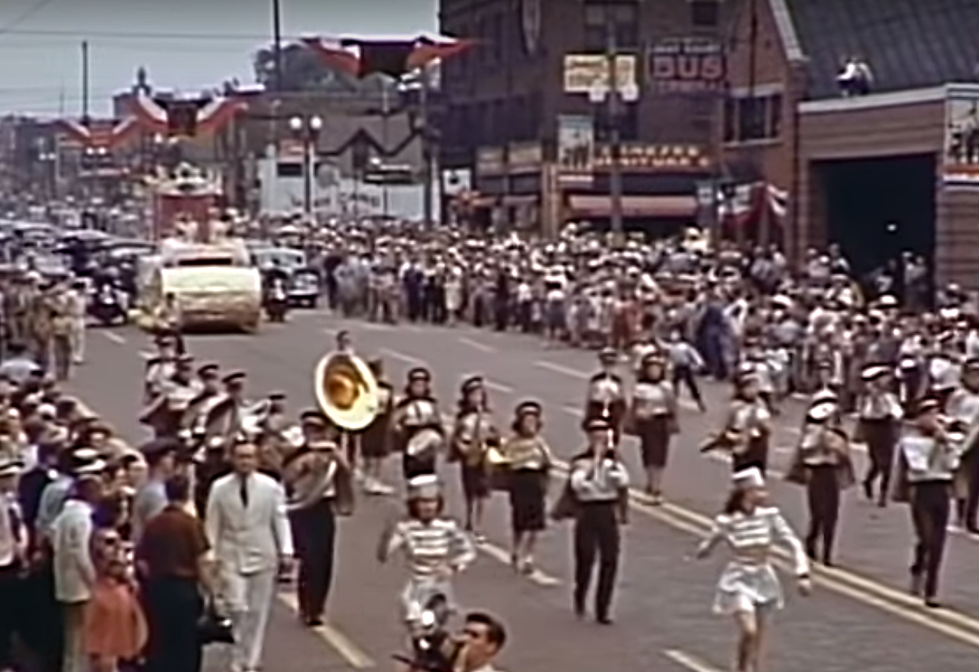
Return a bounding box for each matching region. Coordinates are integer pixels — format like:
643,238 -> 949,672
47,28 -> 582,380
786,402 -> 853,566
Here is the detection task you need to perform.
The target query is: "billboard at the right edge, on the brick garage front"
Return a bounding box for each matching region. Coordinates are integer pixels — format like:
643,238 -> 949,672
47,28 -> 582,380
942,87 -> 979,185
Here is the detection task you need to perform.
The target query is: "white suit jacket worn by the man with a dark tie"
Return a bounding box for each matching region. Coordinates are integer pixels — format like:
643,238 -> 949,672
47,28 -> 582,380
205,473 -> 293,574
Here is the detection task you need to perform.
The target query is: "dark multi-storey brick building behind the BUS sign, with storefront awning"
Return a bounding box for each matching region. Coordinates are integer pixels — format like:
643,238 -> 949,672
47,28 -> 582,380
439,0 -> 730,230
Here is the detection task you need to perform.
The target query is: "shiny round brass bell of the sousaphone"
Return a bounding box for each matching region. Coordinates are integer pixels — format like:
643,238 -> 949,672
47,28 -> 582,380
313,352 -> 380,432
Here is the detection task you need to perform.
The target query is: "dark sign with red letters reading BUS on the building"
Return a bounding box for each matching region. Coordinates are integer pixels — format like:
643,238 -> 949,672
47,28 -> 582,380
648,37 -> 726,93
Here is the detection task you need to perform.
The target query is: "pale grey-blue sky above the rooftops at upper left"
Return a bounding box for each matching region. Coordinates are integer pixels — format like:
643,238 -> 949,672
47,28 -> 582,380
0,0 -> 438,117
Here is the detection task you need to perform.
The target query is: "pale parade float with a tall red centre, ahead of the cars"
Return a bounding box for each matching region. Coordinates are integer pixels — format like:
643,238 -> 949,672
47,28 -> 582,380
138,165 -> 262,331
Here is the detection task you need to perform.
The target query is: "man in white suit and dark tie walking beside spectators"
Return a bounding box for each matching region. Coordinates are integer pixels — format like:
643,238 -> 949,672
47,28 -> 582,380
205,442 -> 293,672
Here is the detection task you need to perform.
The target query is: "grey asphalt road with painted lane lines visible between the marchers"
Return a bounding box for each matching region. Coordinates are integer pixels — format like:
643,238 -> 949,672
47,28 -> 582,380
72,312 -> 979,672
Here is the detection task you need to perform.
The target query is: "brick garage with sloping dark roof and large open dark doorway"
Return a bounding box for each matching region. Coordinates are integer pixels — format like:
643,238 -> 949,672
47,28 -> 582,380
720,0 -> 979,286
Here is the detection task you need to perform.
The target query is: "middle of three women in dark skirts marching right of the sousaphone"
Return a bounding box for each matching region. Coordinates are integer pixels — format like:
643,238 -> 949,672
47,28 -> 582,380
449,376 -> 500,543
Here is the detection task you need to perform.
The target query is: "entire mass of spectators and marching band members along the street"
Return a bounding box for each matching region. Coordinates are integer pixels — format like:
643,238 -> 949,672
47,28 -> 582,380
0,223 -> 979,672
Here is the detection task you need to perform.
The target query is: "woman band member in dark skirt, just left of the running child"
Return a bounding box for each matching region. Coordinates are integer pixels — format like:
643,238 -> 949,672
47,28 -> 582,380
629,351 -> 679,504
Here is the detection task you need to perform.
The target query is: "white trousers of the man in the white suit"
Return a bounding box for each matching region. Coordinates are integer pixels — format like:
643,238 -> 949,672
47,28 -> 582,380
223,570 -> 276,670
